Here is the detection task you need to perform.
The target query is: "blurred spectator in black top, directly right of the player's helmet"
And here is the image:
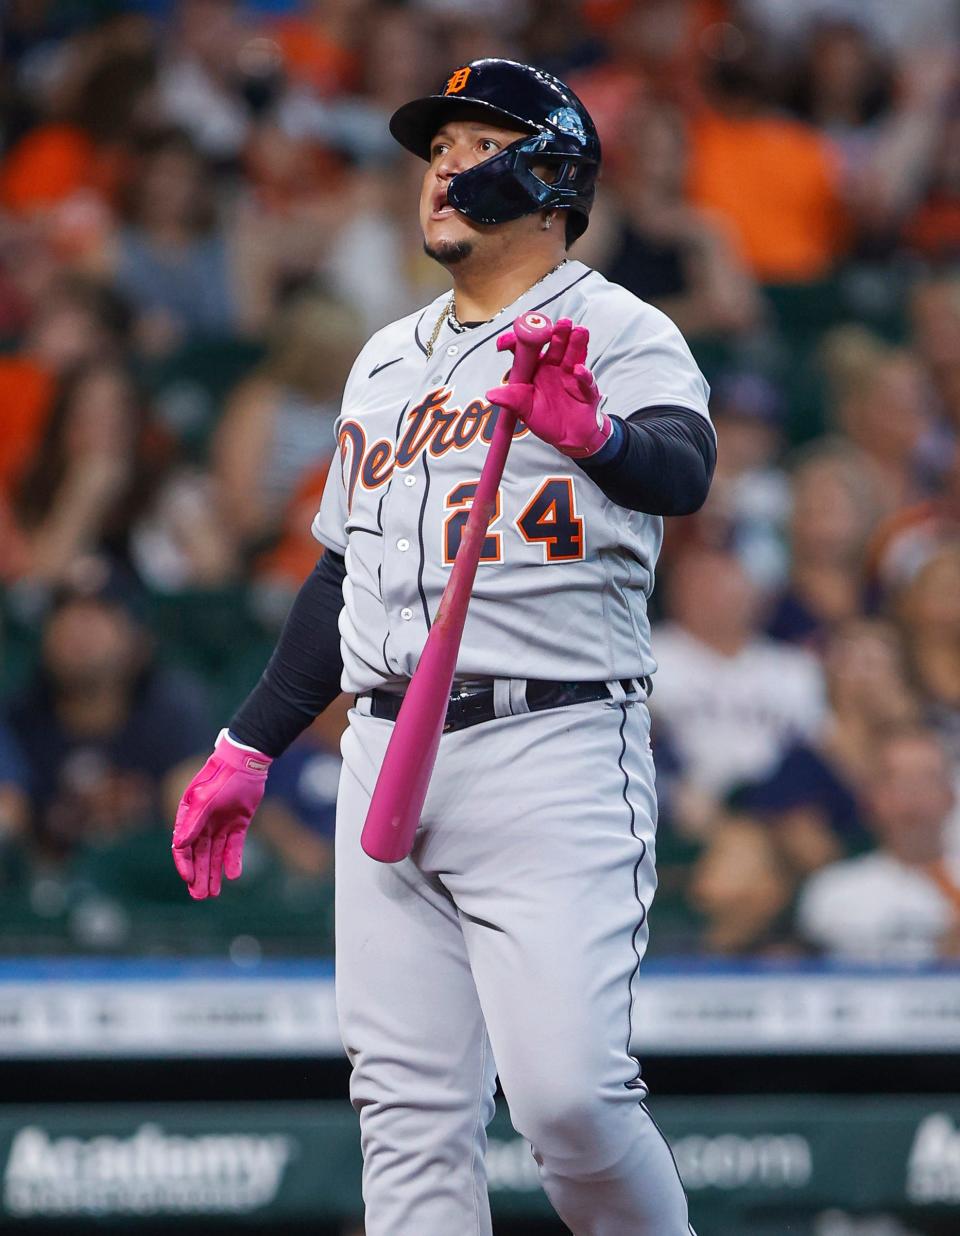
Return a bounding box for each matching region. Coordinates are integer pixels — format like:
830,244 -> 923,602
586,103 -> 759,337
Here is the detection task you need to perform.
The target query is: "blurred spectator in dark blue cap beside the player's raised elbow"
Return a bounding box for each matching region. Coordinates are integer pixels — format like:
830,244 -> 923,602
698,371 -> 791,591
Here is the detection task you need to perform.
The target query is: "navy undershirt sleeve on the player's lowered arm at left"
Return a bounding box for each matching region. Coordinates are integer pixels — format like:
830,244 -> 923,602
229,550 -> 346,755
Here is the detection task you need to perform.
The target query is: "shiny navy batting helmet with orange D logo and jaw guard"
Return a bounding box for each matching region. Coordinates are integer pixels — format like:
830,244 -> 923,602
390,59 -> 600,242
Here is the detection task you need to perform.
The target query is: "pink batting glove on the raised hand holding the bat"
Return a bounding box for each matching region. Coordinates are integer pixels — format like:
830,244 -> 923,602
487,318 -> 613,459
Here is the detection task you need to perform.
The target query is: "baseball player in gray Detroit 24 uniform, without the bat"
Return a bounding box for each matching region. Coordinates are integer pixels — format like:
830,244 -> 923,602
173,59 -> 715,1236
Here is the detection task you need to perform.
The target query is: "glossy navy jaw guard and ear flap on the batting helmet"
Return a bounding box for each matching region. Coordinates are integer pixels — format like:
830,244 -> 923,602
447,133 -> 593,231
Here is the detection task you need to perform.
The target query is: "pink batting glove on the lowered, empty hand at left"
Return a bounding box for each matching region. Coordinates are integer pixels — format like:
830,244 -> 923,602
173,729 -> 273,901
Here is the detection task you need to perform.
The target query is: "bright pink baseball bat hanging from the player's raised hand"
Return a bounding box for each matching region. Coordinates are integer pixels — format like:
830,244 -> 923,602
360,313 -> 554,863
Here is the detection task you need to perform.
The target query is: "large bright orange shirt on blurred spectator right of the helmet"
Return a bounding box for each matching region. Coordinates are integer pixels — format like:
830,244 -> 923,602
688,109 -> 848,283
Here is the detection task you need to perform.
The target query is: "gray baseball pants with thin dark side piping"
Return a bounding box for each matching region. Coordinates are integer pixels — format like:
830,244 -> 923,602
336,685 -> 691,1236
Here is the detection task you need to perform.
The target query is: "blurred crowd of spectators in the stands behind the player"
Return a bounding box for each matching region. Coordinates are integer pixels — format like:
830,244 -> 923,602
0,0 -> 960,962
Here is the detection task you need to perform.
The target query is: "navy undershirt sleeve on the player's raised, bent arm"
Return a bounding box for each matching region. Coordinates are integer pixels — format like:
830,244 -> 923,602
578,407 -> 717,515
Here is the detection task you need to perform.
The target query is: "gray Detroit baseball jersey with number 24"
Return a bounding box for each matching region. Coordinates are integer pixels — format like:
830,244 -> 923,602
314,261 -> 708,692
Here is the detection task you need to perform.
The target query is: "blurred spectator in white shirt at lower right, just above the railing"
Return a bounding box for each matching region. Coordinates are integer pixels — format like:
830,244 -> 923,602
797,728 -> 960,963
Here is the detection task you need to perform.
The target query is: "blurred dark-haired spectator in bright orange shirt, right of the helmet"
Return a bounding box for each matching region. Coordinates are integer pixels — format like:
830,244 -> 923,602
688,23 -> 849,283
